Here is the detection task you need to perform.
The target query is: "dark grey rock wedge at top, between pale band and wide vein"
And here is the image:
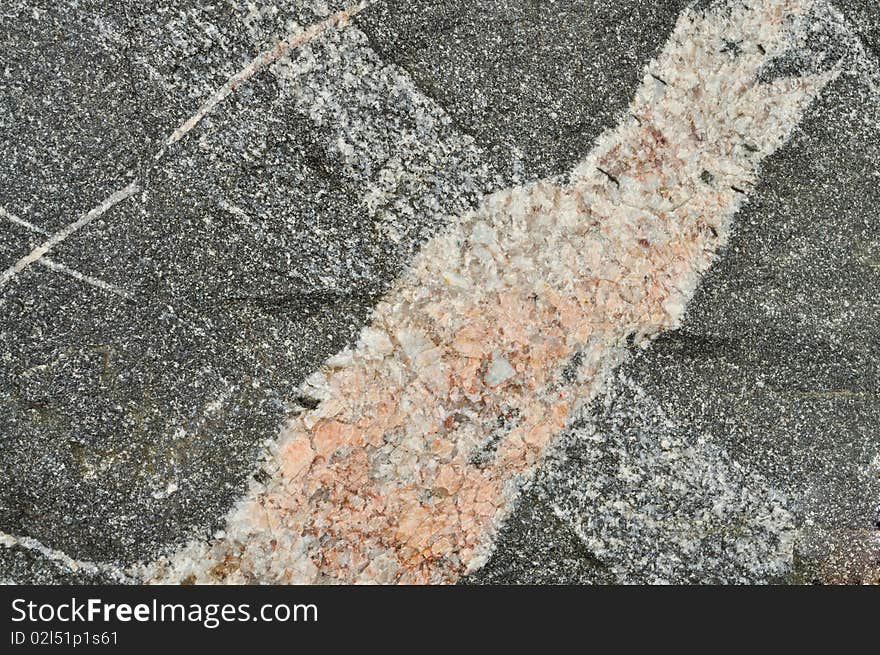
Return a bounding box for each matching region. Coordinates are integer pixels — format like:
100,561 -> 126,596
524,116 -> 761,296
358,0 -> 689,179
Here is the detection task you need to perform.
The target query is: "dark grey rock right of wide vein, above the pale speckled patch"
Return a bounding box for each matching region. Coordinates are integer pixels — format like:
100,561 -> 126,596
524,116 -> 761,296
644,66 -> 880,580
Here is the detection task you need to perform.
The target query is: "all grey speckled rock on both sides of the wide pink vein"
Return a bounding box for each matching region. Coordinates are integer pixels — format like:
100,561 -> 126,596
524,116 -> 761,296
0,0 -> 880,583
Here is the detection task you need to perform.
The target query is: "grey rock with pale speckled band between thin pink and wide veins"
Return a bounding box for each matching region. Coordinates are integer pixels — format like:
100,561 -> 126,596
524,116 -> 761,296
0,6 -> 497,563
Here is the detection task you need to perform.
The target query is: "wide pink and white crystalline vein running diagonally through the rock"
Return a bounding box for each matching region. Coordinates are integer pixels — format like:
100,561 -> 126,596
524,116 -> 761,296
145,0 -> 840,584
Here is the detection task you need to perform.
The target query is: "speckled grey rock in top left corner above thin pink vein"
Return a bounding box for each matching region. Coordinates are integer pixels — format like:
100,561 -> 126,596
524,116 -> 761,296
0,0 -> 348,230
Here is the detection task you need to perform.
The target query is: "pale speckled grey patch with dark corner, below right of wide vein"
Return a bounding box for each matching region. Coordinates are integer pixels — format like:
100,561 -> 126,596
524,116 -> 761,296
469,372 -> 794,584
